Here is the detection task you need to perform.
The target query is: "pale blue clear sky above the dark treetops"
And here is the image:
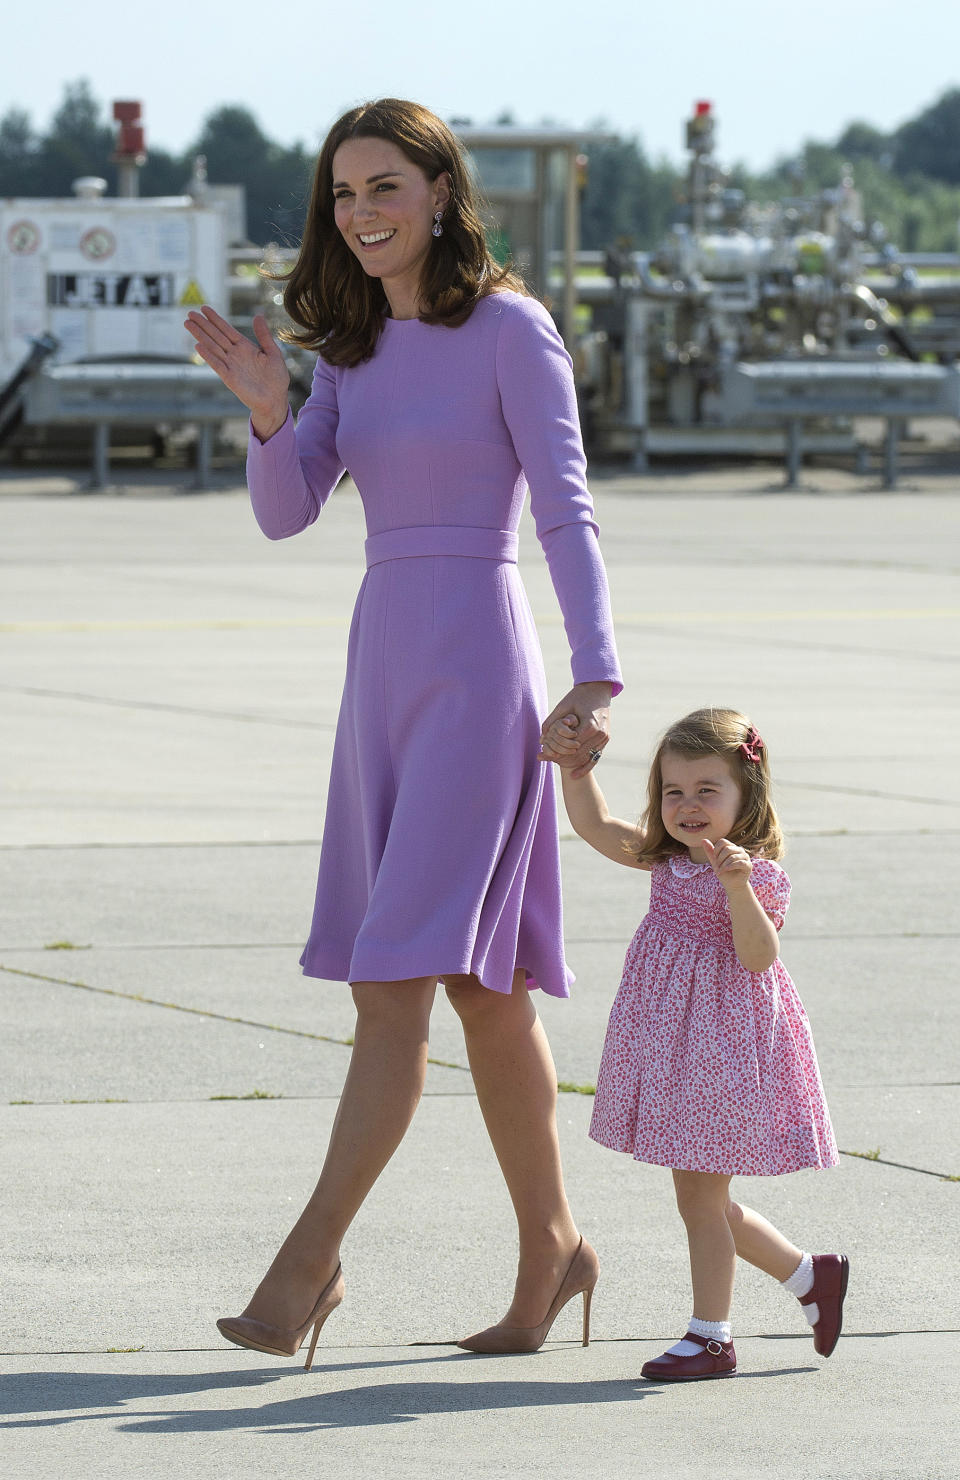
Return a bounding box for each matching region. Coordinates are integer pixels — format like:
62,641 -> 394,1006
7,0 -> 960,167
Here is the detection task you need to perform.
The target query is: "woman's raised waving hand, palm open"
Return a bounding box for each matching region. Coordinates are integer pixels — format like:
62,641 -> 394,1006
183,303 -> 290,441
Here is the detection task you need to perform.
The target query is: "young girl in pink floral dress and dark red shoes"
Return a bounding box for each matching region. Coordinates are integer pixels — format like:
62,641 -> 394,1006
547,709 -> 848,1382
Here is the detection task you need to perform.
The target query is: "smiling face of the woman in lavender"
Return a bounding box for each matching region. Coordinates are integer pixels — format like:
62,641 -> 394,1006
333,138 -> 450,308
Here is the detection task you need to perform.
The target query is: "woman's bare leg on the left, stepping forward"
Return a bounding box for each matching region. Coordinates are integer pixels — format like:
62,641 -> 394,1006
244,977 -> 436,1329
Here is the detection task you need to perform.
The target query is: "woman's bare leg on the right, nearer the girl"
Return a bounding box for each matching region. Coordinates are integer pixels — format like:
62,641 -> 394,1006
445,971 -> 580,1326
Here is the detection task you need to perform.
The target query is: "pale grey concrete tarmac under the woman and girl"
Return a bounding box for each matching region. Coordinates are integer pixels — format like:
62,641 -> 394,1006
0,465 -> 960,1480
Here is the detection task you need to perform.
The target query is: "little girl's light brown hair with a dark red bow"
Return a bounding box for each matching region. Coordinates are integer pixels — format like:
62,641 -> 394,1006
630,709 -> 784,864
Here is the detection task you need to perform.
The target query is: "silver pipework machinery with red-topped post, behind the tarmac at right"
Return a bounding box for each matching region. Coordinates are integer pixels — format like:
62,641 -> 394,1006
577,104 -> 960,484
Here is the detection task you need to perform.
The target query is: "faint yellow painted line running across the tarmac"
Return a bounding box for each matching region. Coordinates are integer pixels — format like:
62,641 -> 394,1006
0,607 -> 960,633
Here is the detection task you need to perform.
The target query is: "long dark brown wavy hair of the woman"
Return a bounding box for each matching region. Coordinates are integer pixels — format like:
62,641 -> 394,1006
272,98 -> 527,366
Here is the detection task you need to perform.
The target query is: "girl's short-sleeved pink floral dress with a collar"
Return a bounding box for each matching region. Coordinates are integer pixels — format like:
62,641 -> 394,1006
590,854 -> 839,1177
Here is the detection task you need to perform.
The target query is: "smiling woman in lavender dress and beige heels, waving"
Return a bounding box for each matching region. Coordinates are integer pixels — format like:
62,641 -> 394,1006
186,99 -> 621,1366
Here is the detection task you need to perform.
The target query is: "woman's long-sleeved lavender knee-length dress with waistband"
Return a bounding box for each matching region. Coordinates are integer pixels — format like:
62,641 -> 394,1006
247,293 -> 621,998
